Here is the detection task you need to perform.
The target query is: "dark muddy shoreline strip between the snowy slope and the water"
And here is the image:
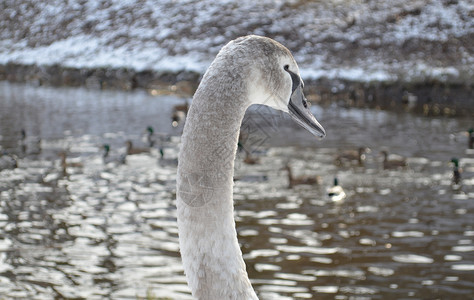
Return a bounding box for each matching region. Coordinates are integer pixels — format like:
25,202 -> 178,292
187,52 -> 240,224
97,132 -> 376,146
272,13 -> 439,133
0,63 -> 474,117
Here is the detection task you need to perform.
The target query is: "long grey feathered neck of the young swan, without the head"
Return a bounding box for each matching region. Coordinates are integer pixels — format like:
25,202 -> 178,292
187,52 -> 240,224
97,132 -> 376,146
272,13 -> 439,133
177,77 -> 257,299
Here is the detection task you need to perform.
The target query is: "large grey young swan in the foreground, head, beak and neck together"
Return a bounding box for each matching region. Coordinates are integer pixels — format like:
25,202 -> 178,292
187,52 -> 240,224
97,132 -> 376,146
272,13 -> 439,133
176,36 -> 325,300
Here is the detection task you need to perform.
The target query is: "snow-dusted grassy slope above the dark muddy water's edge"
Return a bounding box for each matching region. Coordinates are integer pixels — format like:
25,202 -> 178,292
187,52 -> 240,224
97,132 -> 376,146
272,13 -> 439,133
0,0 -> 474,81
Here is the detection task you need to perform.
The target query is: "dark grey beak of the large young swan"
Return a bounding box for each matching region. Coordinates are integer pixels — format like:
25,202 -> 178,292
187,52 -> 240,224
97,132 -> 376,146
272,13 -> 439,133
288,85 -> 326,138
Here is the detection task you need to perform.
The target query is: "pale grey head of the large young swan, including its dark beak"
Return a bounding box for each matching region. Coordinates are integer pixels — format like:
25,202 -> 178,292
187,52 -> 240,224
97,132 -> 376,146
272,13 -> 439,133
233,35 -> 326,138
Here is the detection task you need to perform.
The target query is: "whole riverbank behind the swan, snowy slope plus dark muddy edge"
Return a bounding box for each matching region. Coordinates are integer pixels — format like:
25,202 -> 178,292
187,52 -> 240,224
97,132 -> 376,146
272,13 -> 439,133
0,0 -> 474,116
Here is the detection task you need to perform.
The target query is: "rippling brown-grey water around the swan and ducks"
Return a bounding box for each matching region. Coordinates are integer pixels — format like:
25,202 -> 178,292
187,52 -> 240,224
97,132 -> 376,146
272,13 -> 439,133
0,83 -> 474,299
